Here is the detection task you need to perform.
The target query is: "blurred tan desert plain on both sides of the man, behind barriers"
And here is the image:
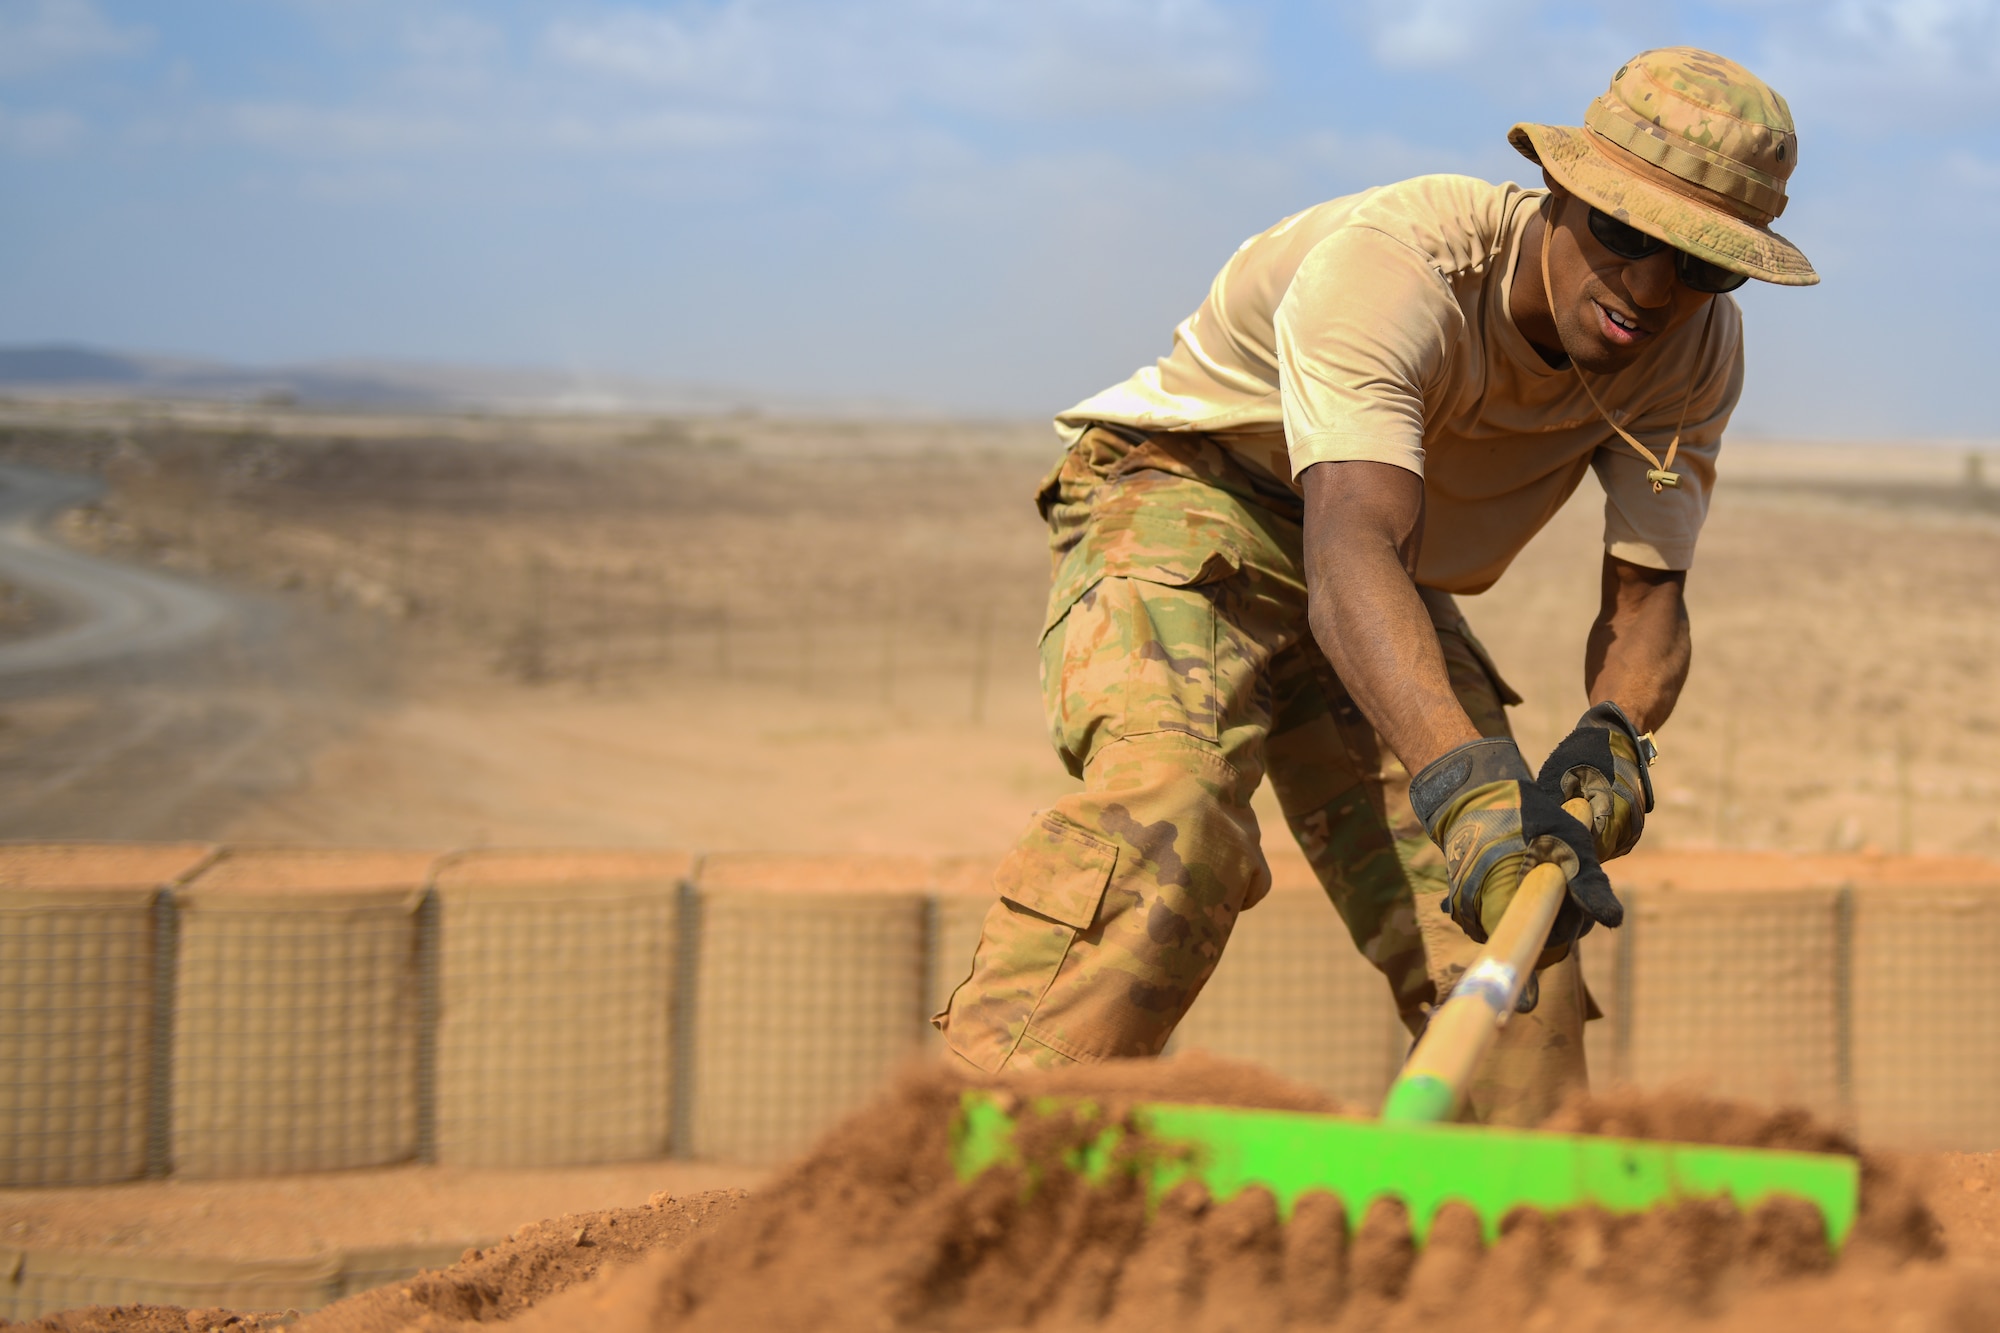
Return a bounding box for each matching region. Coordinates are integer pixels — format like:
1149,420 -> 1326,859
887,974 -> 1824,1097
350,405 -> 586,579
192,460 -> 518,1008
0,406 -> 2000,855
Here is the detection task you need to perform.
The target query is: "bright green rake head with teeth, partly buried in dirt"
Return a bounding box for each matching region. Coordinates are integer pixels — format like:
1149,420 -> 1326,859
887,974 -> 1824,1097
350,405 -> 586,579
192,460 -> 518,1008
952,1091 -> 1860,1253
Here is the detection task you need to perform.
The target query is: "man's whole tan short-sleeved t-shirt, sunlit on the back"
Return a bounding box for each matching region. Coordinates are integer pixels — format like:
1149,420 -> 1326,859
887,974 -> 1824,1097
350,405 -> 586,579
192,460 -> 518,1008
1056,176 -> 1742,592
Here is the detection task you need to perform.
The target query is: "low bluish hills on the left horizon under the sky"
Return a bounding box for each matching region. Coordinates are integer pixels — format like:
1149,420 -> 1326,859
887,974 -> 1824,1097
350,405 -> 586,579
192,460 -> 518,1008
0,344 -> 772,412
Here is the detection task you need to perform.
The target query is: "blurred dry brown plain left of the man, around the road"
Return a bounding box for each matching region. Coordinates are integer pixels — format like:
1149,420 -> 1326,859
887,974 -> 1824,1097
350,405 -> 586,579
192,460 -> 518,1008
0,400 -> 1064,849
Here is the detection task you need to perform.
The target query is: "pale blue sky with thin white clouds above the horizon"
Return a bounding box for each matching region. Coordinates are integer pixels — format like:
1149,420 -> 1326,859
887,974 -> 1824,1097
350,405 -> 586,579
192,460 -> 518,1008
0,0 -> 2000,438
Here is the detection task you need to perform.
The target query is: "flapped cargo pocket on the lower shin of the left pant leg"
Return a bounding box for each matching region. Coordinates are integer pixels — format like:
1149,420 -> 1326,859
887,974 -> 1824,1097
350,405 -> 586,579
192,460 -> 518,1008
936,811 -> 1118,1073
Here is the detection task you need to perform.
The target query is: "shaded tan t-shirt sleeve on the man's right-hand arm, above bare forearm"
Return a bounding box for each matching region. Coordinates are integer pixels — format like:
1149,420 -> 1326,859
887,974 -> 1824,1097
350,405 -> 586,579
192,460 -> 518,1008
1590,298 -> 1744,568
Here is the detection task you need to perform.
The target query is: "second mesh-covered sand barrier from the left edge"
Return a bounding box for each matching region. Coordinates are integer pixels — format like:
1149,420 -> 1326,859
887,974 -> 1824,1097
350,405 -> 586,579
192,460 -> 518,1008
172,849 -> 434,1177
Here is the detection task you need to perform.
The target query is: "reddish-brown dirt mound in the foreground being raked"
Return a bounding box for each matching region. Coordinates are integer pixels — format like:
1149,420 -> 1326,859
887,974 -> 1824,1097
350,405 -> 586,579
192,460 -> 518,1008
11,1057 -> 2000,1333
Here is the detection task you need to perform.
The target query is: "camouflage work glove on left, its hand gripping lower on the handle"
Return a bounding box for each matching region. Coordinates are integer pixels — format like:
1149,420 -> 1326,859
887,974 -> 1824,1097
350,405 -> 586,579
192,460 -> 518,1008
1410,739 -> 1624,967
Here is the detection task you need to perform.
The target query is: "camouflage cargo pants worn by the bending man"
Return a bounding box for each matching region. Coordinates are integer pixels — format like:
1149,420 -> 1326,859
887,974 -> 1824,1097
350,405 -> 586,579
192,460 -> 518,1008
936,428 -> 1594,1125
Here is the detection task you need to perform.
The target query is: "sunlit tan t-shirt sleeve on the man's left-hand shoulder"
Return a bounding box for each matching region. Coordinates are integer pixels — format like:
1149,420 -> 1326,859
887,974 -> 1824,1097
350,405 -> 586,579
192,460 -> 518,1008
1274,226 -> 1464,478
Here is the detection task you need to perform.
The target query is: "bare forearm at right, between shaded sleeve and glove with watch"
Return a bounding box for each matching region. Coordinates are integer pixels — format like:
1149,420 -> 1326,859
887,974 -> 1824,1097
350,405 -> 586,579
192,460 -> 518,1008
1584,554 -> 1694,731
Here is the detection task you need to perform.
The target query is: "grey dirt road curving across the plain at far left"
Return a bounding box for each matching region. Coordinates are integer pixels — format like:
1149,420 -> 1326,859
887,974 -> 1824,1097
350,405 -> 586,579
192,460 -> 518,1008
0,464 -> 384,839
